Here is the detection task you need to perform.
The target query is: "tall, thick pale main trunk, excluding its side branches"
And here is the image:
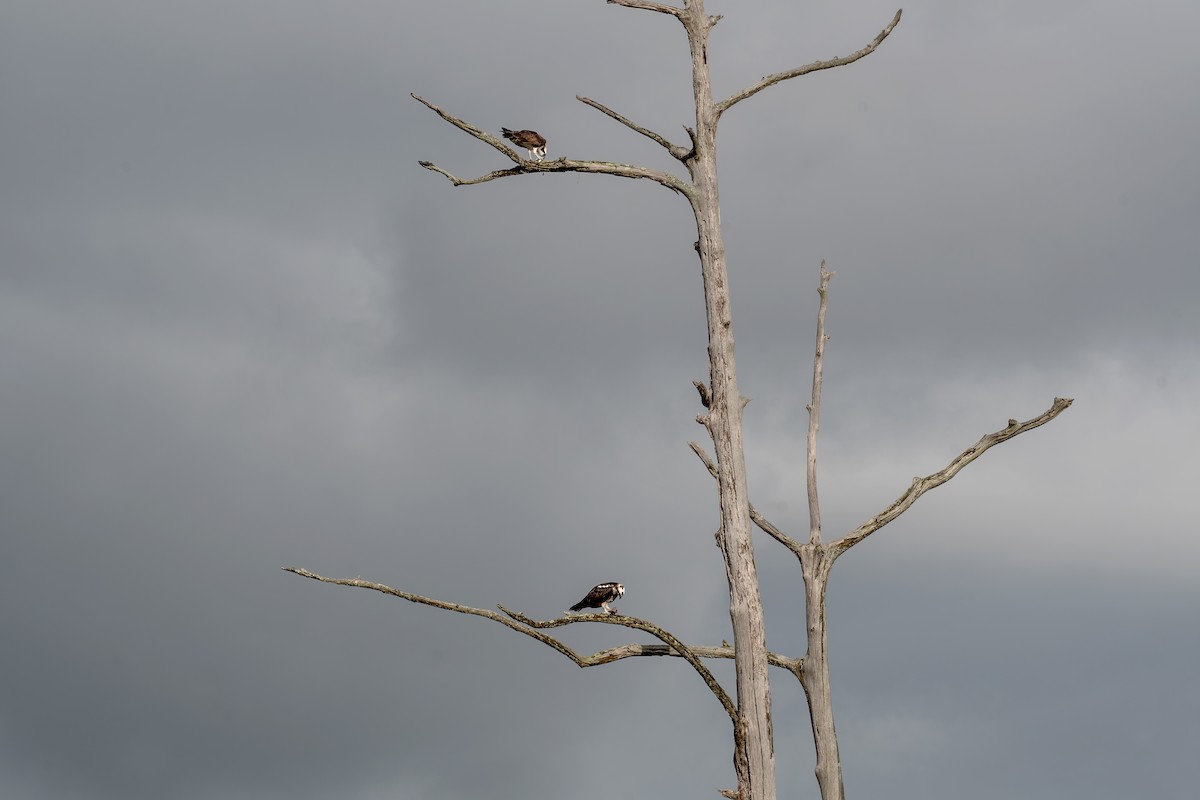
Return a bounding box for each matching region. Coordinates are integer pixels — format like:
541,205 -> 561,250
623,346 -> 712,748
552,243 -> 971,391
683,0 -> 775,800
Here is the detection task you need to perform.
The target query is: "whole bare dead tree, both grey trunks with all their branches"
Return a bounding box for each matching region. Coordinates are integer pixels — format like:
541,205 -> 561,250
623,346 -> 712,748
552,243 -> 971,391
284,6 -> 1070,800
